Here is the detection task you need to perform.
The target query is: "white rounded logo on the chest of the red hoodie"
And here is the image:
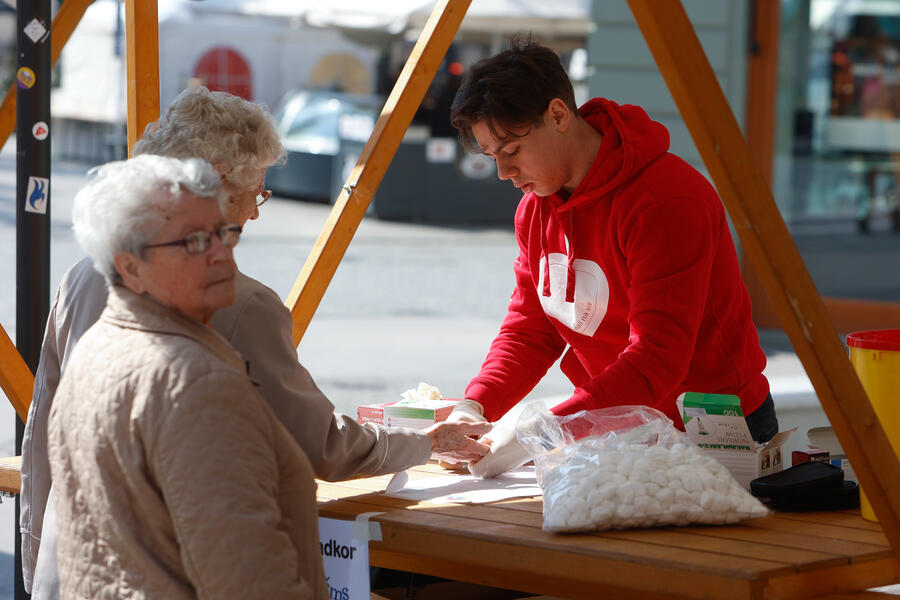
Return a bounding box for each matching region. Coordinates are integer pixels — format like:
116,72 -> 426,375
537,253 -> 609,337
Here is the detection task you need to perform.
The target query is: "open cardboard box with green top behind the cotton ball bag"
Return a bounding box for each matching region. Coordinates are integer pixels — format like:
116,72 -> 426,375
677,392 -> 794,489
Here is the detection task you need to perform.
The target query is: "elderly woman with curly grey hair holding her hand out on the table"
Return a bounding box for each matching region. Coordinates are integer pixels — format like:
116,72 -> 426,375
20,87 -> 490,600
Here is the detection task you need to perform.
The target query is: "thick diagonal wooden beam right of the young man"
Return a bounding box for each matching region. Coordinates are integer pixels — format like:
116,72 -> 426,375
628,0 -> 900,556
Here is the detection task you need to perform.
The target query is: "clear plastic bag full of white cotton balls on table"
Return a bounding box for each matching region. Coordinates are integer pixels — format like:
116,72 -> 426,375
516,406 -> 769,532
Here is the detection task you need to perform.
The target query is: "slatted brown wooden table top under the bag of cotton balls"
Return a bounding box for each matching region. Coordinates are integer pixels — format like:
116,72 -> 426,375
318,465 -> 900,600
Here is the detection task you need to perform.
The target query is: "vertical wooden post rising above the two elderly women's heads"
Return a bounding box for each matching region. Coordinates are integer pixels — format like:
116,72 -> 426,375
125,0 -> 159,156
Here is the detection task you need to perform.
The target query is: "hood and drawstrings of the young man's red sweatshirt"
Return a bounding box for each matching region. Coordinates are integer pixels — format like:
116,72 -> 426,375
540,98 -> 669,302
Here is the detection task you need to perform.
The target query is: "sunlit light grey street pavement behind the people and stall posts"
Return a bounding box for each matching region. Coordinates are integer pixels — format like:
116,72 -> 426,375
0,140 -> 893,598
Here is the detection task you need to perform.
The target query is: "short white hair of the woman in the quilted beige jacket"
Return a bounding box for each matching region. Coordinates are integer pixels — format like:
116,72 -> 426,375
72,154 -> 222,285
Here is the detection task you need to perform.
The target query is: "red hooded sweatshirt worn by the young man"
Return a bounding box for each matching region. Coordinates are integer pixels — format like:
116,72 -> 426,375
466,98 -> 769,427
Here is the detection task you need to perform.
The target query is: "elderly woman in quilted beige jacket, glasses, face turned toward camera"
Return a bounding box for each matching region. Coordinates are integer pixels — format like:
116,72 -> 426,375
49,156 -> 329,599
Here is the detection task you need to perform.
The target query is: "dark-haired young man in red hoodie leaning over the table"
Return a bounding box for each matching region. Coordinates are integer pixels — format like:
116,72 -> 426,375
451,40 -> 778,476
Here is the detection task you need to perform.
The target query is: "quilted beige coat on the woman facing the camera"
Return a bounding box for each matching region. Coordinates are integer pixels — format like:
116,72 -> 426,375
49,288 -> 328,600
